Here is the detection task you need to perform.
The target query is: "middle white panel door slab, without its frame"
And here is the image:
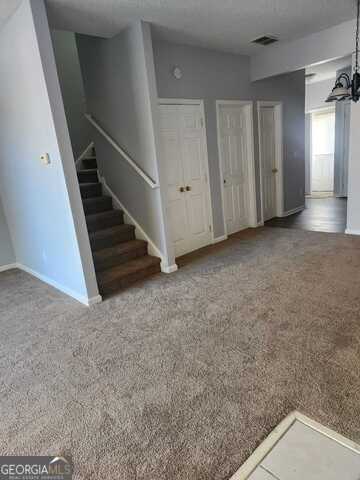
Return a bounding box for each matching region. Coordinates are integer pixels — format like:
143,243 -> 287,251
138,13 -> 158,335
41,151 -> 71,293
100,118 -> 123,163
218,104 -> 250,235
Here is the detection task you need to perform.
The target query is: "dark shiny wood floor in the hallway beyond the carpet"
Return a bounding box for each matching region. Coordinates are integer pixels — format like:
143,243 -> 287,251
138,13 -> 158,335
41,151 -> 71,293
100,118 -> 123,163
265,197 -> 347,233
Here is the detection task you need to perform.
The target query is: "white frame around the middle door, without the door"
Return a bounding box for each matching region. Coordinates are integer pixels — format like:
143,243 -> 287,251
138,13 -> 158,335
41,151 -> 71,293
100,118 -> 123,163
216,100 -> 258,237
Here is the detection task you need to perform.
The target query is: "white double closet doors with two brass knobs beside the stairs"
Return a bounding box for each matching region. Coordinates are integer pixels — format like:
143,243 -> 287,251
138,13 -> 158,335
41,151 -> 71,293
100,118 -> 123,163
159,105 -> 211,257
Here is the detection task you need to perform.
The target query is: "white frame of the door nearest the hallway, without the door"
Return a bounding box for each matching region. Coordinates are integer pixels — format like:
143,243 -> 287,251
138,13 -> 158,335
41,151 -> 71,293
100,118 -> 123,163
257,100 -> 285,224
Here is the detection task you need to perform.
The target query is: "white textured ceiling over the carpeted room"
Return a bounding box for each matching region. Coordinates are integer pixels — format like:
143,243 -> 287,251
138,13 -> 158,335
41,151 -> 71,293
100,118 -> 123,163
0,0 -> 355,54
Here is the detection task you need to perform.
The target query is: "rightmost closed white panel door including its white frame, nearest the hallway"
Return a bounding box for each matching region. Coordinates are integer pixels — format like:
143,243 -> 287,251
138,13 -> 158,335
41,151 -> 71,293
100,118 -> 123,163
258,102 -> 284,222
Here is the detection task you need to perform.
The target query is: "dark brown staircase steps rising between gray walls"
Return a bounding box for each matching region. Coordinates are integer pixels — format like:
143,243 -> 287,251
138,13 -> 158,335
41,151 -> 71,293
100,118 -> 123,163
78,149 -> 160,295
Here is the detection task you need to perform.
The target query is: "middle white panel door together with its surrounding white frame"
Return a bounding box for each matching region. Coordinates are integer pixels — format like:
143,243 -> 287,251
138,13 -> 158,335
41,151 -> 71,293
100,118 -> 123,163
216,100 -> 257,235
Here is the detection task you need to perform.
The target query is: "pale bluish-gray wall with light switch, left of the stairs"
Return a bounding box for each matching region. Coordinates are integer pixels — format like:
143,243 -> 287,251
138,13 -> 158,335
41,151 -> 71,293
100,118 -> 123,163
0,0 -> 98,301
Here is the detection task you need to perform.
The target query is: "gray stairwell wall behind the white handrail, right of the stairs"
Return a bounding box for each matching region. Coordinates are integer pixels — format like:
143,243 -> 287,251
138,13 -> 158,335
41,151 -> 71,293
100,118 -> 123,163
77,22 -> 172,262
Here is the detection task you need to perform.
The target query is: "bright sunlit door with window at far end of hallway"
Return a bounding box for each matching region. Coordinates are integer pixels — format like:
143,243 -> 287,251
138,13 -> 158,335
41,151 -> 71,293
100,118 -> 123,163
311,109 -> 335,198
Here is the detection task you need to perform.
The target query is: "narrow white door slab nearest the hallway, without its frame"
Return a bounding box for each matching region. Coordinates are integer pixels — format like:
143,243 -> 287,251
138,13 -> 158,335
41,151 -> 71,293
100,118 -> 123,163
259,106 -> 278,222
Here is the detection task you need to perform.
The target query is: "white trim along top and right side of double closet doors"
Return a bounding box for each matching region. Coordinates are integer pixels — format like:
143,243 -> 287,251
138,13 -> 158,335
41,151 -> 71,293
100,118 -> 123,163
158,98 -> 216,248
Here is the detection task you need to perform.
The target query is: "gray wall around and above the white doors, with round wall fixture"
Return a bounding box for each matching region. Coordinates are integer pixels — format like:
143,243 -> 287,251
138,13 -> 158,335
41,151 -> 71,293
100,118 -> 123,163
154,40 -> 305,236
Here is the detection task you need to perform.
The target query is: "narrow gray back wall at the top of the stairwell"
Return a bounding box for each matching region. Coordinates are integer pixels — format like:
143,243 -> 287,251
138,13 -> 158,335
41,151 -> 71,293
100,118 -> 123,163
51,30 -> 92,159
